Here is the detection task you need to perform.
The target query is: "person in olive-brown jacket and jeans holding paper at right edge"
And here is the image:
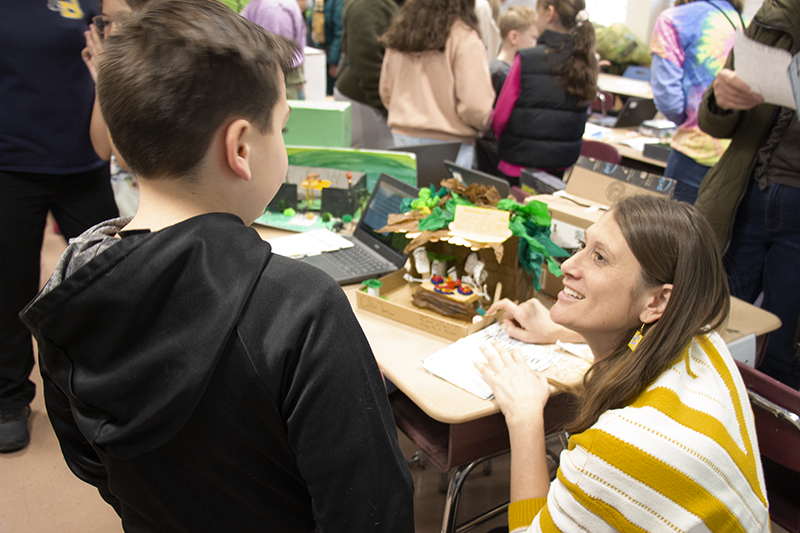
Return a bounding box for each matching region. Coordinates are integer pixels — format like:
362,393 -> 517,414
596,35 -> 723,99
695,0 -> 800,389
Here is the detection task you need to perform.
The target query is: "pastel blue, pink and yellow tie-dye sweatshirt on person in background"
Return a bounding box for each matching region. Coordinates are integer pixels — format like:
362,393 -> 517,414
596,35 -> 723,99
650,0 -> 742,166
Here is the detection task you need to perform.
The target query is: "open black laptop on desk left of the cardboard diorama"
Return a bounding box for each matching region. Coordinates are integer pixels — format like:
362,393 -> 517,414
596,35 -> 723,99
300,174 -> 419,285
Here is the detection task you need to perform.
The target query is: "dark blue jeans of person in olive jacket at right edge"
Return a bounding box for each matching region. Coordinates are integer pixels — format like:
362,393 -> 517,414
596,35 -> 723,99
723,181 -> 800,389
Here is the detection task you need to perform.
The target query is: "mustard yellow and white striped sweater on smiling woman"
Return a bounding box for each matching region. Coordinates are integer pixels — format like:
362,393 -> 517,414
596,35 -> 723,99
509,333 -> 770,533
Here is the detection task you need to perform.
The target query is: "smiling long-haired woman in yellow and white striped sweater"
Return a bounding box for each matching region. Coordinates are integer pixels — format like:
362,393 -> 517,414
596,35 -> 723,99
478,197 -> 769,532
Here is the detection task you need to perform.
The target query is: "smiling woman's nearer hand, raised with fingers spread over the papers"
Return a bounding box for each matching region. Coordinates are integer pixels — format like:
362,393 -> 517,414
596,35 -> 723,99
475,343 -> 550,431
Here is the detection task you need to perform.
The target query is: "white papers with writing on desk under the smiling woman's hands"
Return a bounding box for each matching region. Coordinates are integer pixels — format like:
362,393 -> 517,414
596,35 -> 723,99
422,323 -> 561,400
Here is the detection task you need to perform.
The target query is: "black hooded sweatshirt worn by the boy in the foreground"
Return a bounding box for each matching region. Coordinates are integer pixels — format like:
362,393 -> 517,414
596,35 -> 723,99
21,214 -> 413,532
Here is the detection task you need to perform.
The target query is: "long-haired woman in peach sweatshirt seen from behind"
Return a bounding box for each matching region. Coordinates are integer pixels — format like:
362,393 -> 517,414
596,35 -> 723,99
379,0 -> 494,168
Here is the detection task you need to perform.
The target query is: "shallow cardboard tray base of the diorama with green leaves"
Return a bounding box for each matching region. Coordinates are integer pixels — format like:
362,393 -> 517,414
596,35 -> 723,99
356,269 -> 496,341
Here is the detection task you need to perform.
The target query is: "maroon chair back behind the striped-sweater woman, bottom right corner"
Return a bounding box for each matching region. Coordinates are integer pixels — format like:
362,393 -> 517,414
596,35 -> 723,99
736,361 -> 800,533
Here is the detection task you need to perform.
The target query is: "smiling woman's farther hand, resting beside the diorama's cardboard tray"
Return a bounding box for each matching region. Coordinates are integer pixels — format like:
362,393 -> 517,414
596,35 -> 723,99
487,298 -> 583,344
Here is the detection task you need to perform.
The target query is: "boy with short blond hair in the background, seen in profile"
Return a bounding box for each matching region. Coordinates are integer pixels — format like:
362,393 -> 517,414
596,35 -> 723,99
489,6 -> 539,102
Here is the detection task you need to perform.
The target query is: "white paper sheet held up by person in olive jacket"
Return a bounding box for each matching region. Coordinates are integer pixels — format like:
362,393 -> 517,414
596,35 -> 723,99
733,31 -> 797,109
